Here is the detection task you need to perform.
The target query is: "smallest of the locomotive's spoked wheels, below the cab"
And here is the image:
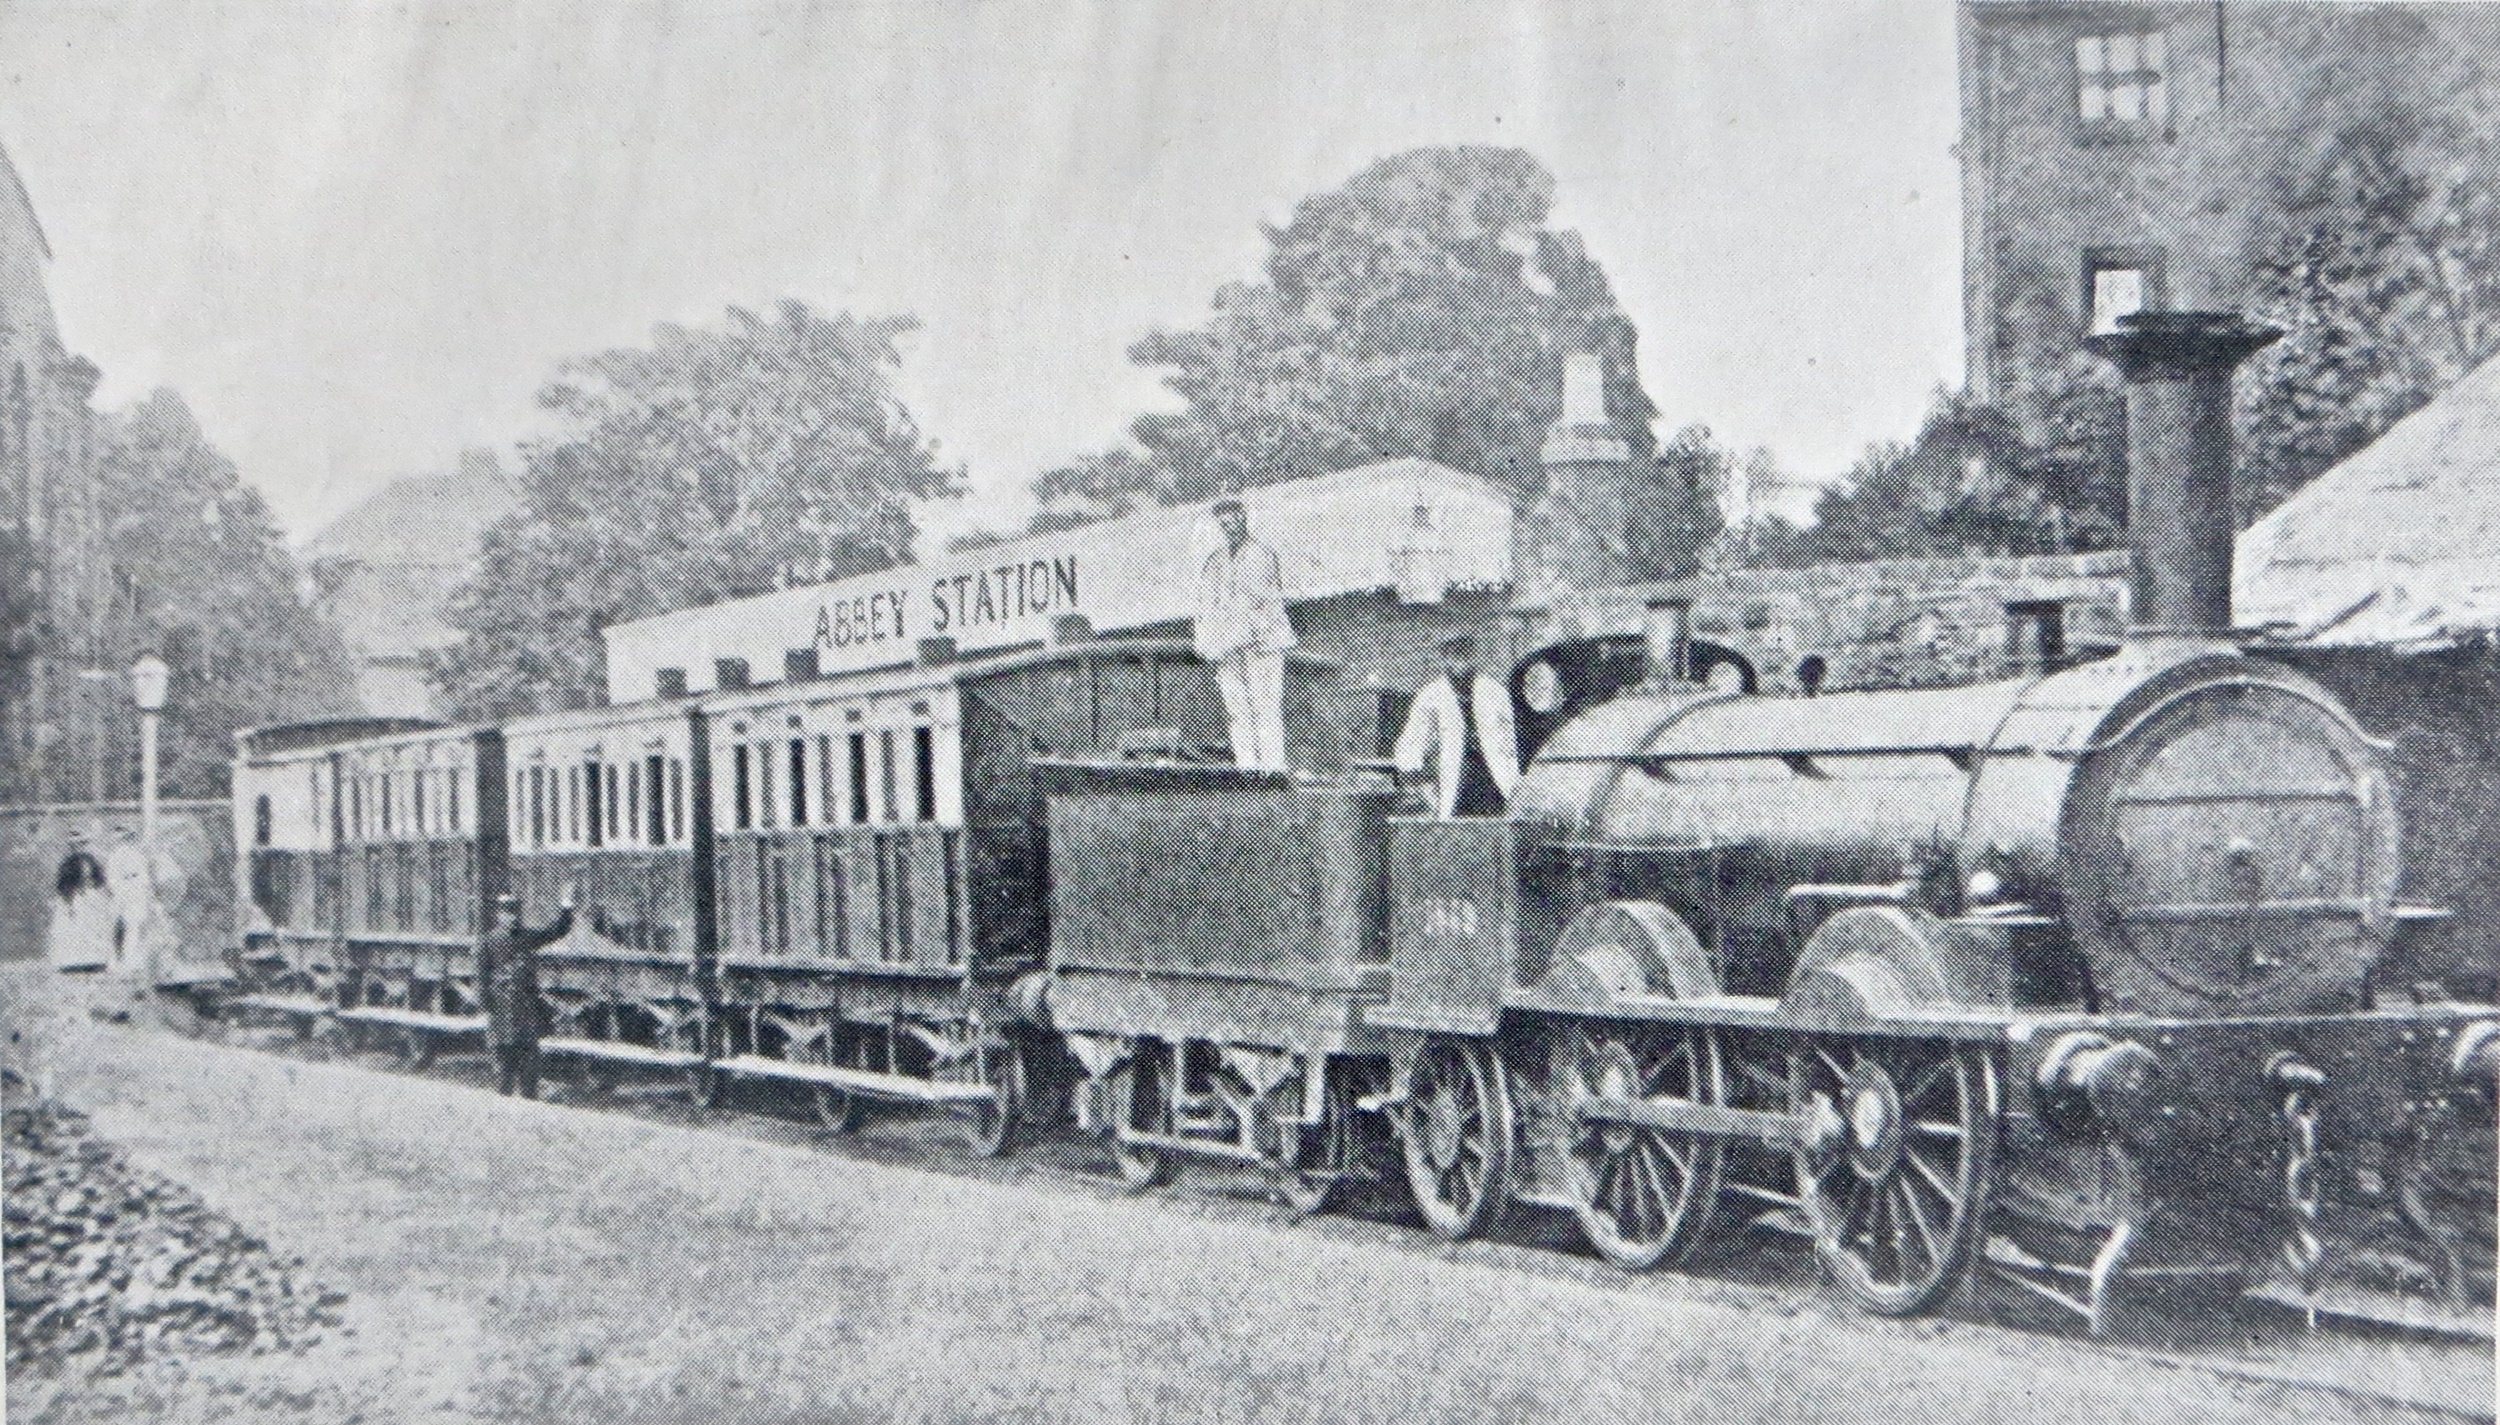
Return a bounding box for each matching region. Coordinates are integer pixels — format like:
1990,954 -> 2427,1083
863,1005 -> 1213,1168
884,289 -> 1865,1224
1398,1038 -> 1513,1243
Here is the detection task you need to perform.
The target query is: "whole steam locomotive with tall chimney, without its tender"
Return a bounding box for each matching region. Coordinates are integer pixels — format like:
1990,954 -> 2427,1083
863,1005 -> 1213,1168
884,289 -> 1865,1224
1365,313 -> 2500,1328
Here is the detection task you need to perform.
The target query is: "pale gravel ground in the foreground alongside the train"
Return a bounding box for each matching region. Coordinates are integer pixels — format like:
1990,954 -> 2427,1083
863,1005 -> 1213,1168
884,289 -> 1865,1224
10,960 -> 2490,1425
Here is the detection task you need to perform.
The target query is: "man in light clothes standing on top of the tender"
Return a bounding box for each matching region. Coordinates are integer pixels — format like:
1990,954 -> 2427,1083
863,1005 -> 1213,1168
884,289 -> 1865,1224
1193,495 -> 1295,773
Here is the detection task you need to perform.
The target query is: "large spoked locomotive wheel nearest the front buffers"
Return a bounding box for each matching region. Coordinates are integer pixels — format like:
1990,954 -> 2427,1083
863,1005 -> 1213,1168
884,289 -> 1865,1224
1788,1040 -> 2000,1315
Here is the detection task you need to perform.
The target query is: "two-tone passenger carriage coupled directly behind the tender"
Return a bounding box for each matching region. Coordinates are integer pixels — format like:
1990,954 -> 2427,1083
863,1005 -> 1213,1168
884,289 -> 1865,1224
700,633 -> 1333,1153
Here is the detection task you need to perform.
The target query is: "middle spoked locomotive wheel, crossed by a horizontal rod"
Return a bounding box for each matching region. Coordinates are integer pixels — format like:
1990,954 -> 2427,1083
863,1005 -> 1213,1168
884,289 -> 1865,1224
1558,1025 -> 1728,1273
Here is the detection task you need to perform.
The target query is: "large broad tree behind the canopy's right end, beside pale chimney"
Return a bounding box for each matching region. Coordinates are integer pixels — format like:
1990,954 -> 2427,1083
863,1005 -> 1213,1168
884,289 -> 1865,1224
1125,148 -> 1655,505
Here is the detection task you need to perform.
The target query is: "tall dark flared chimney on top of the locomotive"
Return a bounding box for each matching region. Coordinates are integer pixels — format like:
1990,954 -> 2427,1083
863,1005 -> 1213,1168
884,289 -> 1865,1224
2085,313 -> 2283,640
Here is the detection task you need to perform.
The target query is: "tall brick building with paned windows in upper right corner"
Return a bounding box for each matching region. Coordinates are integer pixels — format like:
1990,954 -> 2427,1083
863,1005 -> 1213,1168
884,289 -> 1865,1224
1960,0 -> 2500,400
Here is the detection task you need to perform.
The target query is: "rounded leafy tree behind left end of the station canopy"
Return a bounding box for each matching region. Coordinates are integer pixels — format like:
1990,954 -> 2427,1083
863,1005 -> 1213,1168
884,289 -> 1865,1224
428,300 -> 955,718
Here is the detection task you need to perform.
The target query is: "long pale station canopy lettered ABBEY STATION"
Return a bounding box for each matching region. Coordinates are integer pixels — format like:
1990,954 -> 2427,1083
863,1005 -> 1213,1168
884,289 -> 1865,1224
603,460 -> 1518,703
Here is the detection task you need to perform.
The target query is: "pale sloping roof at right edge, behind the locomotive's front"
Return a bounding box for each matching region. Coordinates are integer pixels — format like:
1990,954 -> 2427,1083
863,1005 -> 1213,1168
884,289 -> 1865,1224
2233,358 -> 2500,653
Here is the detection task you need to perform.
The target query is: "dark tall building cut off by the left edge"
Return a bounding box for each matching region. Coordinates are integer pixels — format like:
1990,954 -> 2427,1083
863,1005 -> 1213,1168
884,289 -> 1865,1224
0,138 -> 106,803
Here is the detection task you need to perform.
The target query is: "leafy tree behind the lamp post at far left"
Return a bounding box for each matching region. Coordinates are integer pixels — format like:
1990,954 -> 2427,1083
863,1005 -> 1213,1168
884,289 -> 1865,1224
93,390 -> 355,798
